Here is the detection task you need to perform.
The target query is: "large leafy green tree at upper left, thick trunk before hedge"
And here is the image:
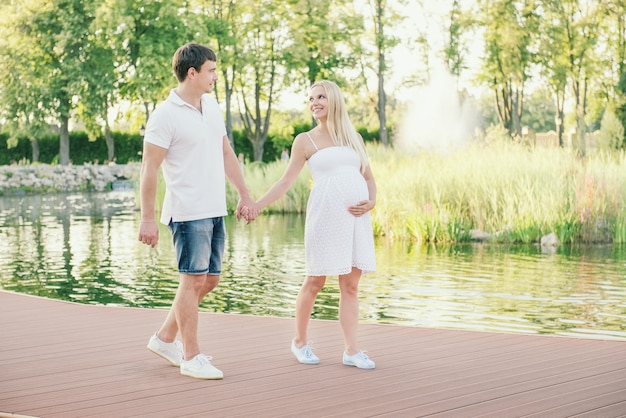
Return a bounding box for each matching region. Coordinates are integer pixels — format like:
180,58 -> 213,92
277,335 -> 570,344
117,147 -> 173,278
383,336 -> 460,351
0,0 -> 100,165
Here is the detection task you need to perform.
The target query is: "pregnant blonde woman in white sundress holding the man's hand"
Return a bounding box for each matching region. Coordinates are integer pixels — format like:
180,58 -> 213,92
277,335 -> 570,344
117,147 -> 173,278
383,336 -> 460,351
253,81 -> 376,369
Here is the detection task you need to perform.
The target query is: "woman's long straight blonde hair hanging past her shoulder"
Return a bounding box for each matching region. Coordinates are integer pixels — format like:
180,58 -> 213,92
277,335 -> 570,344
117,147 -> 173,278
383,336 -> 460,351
311,80 -> 369,172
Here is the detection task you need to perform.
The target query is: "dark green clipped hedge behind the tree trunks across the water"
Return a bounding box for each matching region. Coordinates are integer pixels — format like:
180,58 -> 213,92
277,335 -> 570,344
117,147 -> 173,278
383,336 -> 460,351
0,123 -> 388,165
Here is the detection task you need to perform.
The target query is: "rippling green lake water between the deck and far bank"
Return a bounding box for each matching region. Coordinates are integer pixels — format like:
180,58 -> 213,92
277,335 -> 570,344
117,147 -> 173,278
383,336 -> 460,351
0,190 -> 626,340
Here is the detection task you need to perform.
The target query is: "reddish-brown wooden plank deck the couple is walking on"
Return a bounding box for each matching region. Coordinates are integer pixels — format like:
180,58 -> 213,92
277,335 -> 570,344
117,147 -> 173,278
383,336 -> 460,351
0,291 -> 626,418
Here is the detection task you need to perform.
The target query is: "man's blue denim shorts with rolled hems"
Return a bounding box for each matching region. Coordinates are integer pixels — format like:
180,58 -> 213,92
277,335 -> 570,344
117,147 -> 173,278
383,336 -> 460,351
169,217 -> 226,275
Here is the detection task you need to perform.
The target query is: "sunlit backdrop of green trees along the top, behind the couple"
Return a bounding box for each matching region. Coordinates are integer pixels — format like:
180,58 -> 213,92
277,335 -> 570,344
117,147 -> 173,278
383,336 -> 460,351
0,0 -> 626,163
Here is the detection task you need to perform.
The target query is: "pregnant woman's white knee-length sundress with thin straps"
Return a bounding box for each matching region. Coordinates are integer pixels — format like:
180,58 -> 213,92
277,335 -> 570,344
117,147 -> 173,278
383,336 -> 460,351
304,133 -> 376,276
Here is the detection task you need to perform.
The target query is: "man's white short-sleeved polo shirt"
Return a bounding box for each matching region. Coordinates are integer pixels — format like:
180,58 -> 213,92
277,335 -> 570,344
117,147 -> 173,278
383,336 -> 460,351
144,90 -> 228,225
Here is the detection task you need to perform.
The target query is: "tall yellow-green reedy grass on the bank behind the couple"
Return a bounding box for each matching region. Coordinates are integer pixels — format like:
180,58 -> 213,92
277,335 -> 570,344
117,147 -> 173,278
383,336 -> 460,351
228,131 -> 626,244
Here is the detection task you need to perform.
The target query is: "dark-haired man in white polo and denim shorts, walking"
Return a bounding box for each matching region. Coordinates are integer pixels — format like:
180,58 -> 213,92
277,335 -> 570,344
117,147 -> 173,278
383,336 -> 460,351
139,43 -> 255,379
